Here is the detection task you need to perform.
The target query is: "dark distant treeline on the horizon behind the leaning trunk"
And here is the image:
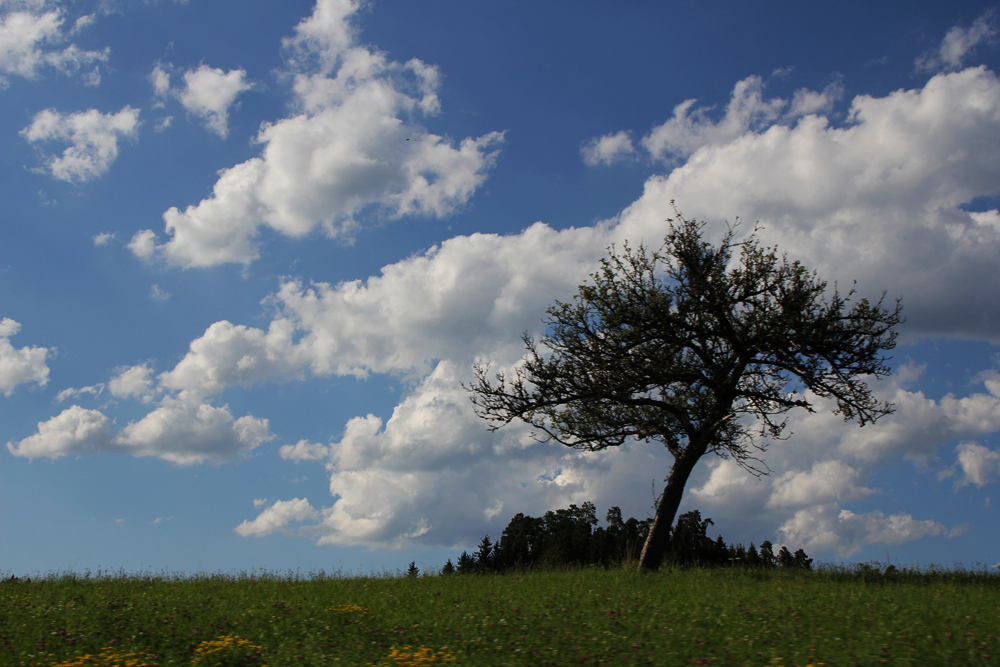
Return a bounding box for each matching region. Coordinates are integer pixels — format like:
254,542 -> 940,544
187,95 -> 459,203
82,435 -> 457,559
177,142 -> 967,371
441,502 -> 812,574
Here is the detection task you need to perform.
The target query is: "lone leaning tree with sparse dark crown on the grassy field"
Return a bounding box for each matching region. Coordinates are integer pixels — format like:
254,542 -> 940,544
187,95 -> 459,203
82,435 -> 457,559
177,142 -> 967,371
467,215 -> 903,570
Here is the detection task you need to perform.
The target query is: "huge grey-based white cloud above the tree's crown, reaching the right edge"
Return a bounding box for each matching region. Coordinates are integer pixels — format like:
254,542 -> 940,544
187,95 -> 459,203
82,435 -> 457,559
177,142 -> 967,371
620,68 -> 1000,340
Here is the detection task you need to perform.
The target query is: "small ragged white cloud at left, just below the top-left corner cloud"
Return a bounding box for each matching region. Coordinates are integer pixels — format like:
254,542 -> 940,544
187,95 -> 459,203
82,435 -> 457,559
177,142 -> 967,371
21,106 -> 139,183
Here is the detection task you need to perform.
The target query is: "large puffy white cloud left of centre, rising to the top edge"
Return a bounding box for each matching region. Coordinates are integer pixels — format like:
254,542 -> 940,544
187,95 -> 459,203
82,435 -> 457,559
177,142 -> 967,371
132,0 -> 503,267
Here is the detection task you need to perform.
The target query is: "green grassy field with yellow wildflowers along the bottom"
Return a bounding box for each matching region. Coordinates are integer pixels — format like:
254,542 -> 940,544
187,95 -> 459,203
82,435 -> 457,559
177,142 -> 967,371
0,566 -> 1000,667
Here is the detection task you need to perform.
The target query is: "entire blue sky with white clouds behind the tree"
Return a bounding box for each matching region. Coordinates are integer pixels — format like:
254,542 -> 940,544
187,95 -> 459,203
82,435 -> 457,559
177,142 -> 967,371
0,0 -> 1000,575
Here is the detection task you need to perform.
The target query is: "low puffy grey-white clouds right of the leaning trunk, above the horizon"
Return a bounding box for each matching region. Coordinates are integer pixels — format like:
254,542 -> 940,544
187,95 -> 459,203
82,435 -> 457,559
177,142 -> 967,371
689,369 -> 1000,558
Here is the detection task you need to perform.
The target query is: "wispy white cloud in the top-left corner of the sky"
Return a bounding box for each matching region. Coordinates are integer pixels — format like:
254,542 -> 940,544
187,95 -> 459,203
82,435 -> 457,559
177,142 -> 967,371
0,3 -> 110,88
